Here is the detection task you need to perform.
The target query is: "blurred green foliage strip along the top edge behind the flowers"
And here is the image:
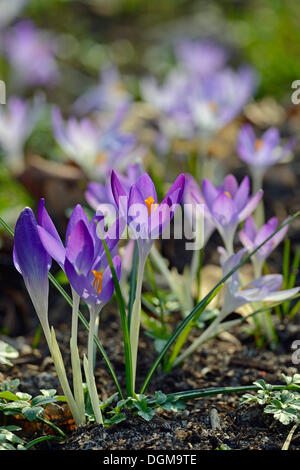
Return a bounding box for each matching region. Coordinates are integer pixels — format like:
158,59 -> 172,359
26,0 -> 300,99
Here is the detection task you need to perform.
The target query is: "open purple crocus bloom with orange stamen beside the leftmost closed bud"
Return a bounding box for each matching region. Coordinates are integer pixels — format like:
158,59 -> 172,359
38,199 -> 121,311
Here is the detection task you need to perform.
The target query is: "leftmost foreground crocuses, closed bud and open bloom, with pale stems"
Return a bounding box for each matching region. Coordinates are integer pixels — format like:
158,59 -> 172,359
14,200 -> 121,425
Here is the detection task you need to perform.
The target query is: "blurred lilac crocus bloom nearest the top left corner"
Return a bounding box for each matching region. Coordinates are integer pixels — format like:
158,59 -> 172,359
4,20 -> 59,86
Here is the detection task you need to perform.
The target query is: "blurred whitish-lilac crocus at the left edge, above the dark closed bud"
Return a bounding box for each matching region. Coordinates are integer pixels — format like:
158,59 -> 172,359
0,95 -> 44,172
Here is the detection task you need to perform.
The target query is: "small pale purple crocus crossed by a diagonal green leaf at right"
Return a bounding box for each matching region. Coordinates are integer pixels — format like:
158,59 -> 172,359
239,215 -> 288,277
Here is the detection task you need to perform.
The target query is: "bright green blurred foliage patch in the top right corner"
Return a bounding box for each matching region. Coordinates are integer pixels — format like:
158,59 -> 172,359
228,0 -> 300,99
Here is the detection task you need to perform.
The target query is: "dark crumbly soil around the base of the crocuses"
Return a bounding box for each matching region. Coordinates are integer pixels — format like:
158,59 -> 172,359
0,302 -> 300,450
